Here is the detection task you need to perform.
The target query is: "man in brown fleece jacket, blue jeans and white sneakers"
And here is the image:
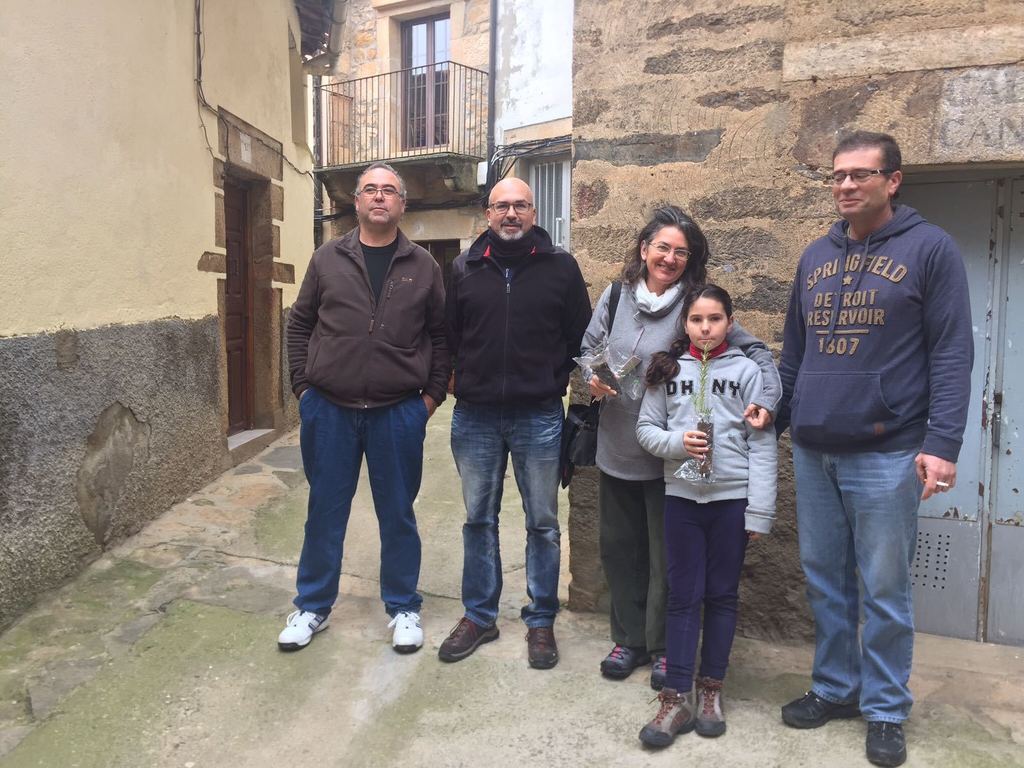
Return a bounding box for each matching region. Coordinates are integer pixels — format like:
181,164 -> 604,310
278,163 -> 451,653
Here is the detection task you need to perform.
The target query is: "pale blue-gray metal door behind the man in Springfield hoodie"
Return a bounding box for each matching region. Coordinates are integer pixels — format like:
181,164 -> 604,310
901,177 -> 1024,642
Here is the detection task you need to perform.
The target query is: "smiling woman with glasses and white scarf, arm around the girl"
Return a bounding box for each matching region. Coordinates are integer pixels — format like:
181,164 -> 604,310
583,206 -> 782,690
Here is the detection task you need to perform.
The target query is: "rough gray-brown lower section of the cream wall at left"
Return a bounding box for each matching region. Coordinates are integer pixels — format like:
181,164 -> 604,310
0,317 -> 222,629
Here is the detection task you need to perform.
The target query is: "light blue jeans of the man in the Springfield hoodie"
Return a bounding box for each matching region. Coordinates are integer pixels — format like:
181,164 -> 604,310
793,444 -> 922,723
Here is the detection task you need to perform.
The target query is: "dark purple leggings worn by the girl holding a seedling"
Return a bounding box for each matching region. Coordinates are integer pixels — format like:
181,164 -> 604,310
665,496 -> 746,693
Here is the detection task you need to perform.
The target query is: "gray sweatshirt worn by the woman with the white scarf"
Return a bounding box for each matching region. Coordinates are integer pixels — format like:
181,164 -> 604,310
583,284 -> 782,480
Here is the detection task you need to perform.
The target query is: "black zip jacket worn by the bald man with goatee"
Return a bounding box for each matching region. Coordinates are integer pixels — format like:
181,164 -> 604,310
445,226 -> 591,404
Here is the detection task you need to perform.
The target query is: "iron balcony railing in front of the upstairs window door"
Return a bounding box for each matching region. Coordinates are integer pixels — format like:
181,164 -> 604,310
321,61 -> 487,167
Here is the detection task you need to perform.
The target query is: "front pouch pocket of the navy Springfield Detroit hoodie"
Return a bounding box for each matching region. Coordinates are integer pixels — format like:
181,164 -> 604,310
791,372 -> 898,445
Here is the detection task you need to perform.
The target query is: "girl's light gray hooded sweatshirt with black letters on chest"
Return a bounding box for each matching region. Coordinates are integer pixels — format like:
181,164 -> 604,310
634,346 -> 777,534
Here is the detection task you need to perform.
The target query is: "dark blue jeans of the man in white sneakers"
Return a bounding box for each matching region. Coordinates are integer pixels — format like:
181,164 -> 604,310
294,389 -> 428,616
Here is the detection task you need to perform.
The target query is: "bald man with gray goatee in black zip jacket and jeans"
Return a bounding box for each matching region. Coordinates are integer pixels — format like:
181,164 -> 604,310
438,178 -> 591,669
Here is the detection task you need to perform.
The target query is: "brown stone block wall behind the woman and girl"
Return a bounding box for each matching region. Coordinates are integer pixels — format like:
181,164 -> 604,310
570,0 -> 1024,638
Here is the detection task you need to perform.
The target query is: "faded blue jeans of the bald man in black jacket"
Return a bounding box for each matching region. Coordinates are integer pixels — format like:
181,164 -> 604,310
452,399 -> 564,627
